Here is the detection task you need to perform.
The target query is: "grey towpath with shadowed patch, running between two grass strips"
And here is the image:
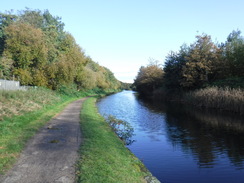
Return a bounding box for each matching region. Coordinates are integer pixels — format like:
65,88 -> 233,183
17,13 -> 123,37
0,99 -> 85,183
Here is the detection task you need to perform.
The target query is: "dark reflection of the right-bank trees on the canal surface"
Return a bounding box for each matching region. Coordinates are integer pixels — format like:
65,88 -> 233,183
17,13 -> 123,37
140,99 -> 244,169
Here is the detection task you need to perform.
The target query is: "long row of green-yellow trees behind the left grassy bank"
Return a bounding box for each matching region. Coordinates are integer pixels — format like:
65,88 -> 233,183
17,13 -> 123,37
0,9 -> 122,89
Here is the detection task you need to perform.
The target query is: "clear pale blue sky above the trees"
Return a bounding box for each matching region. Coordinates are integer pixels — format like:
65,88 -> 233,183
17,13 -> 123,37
0,0 -> 244,83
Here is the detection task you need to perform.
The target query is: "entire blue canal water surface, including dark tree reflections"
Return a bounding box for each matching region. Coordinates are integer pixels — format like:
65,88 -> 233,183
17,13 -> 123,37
97,91 -> 244,183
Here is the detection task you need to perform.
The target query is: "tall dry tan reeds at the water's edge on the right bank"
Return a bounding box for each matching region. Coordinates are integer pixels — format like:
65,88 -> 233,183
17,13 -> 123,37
185,87 -> 244,114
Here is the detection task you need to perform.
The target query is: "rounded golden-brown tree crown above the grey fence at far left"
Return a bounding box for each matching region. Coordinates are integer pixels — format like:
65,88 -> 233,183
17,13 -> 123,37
4,22 -> 47,69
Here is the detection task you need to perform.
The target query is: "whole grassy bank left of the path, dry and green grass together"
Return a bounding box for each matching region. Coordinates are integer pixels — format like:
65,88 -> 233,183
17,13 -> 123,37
0,88 -> 111,174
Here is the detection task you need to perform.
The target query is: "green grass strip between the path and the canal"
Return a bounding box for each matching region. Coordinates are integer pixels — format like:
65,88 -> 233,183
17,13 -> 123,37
77,98 -> 149,183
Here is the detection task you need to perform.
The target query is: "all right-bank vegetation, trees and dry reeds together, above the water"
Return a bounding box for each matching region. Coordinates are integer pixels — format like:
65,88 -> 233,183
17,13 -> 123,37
133,30 -> 244,114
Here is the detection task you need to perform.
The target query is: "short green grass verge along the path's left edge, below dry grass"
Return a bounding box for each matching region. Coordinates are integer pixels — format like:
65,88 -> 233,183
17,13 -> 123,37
0,94 -> 74,175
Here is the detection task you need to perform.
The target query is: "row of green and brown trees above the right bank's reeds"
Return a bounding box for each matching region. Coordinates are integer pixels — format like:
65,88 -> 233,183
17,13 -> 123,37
133,30 -> 244,96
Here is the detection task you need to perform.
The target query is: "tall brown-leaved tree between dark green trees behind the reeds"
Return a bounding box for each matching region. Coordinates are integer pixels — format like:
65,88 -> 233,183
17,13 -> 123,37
180,34 -> 219,89
